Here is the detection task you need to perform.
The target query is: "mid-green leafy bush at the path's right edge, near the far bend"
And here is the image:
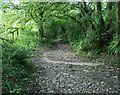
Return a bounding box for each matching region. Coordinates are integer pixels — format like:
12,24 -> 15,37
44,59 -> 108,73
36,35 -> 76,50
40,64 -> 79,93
71,29 -> 96,52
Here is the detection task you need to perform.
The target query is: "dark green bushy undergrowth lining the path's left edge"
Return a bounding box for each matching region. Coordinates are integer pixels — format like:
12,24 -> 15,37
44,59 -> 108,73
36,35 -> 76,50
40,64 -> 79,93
2,42 -> 33,93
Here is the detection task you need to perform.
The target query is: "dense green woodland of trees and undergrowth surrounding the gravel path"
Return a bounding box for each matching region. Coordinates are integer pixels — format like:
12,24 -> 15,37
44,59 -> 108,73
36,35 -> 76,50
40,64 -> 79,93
0,2 -> 120,93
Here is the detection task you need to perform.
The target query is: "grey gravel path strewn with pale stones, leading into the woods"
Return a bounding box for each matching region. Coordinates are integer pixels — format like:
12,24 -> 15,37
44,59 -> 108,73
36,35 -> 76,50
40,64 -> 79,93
32,44 -> 120,93
